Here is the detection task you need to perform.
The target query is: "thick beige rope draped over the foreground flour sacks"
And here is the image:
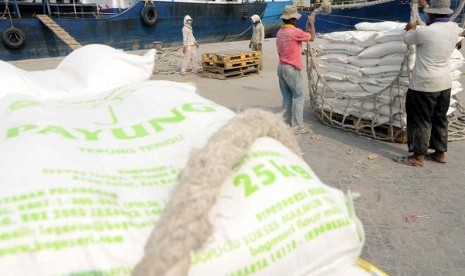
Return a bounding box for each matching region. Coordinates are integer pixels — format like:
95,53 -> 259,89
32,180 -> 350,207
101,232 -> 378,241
133,109 -> 300,276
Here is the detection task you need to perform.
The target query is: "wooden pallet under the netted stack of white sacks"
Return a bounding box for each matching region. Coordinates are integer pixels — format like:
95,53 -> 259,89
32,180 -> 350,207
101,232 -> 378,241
323,111 -> 407,143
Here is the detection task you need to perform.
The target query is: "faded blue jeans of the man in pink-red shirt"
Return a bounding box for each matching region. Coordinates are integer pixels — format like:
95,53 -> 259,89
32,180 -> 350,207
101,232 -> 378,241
278,64 -> 304,126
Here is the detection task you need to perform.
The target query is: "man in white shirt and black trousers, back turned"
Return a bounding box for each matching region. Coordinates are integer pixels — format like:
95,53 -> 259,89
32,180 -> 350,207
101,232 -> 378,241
394,0 -> 462,167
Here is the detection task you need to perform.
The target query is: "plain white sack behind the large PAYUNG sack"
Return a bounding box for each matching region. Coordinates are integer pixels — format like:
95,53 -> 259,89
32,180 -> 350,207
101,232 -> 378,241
30,44 -> 156,98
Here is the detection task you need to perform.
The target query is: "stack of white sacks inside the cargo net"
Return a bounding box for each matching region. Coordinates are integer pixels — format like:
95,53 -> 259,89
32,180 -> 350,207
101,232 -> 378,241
319,22 -> 464,127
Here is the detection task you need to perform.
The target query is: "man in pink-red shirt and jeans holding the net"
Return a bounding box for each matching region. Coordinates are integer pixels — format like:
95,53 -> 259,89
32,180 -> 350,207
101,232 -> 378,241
276,5 -> 315,134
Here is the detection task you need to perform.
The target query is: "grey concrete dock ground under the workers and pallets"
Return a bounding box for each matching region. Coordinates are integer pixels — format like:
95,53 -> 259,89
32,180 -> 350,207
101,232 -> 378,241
11,39 -> 465,276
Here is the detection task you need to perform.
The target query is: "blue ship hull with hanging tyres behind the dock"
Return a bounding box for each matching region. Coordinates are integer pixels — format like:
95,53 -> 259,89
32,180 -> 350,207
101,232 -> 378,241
0,1 -> 290,61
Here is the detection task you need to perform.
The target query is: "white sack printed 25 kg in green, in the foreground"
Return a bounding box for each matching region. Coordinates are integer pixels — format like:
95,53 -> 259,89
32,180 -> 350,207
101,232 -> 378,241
189,137 -> 367,276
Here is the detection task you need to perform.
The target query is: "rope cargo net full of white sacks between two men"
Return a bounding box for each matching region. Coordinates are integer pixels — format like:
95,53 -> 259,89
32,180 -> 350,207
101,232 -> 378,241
307,22 -> 465,143
